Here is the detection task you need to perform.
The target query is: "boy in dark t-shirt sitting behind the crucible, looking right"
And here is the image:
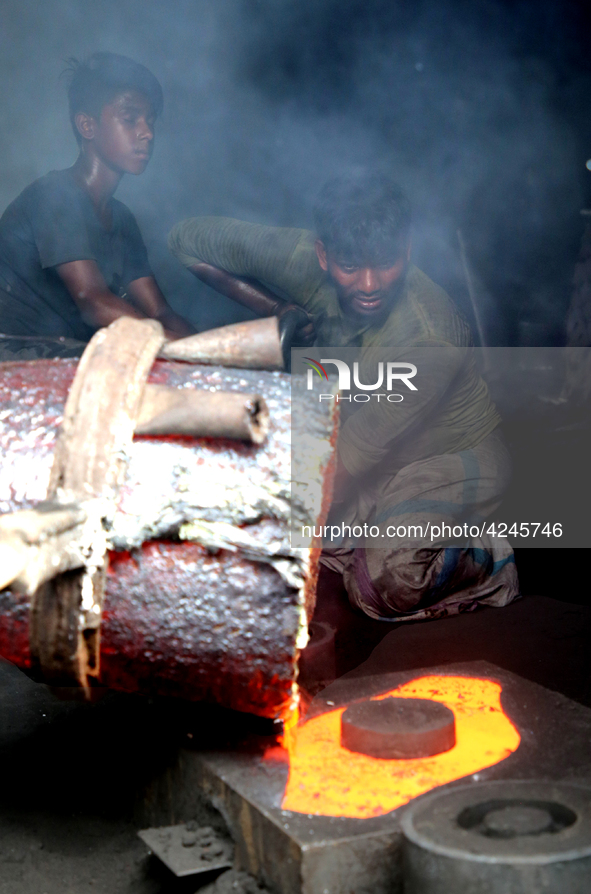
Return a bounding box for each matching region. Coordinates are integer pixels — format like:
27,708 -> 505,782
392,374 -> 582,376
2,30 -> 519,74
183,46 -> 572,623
0,53 -> 195,341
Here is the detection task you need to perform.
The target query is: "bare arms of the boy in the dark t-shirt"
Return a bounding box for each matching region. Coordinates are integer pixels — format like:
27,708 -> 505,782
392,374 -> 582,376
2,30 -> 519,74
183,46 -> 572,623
56,260 -> 194,339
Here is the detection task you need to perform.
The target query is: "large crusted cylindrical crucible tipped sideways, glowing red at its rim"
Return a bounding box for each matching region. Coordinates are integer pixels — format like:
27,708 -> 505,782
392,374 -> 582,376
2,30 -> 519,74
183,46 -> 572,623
0,321 -> 337,719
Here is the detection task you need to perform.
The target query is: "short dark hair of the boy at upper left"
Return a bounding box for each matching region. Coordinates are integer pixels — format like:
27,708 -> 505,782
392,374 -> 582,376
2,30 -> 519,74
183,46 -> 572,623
66,53 -> 164,142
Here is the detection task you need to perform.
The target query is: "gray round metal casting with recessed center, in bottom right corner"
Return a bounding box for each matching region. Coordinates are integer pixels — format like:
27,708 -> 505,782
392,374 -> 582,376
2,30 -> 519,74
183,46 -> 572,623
402,780 -> 591,894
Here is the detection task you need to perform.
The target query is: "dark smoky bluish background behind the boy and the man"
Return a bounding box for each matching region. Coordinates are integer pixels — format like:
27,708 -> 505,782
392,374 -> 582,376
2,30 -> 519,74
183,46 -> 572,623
0,0 -> 591,344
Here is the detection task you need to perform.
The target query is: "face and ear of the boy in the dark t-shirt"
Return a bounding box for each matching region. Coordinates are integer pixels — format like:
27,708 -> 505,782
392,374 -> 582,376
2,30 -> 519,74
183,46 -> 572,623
77,90 -> 155,174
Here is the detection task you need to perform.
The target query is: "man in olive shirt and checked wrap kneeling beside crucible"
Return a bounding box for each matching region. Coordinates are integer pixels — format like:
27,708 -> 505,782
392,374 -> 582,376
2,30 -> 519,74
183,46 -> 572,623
169,173 -> 518,621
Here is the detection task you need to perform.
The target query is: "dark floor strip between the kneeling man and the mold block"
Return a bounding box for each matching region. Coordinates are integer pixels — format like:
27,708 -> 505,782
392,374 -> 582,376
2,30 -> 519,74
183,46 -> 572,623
315,572 -> 591,706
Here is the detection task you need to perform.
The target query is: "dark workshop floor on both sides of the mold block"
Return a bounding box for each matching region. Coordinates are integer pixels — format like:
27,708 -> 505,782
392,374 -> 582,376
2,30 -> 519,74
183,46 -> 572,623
0,577 -> 591,894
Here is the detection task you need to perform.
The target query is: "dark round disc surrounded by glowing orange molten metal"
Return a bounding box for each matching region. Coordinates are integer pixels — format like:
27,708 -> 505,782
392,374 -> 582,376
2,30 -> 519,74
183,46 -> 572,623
341,698 -> 456,759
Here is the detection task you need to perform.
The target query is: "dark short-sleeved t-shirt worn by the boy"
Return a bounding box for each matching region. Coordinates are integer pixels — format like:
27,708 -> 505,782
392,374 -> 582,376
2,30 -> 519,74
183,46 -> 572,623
0,169 -> 152,341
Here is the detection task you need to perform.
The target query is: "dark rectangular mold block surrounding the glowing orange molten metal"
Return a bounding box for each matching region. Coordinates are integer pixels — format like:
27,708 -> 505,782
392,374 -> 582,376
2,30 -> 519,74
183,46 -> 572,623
142,661 -> 591,894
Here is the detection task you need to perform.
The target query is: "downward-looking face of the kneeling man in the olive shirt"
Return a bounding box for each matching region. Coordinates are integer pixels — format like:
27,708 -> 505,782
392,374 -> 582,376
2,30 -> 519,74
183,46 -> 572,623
316,241 -> 410,324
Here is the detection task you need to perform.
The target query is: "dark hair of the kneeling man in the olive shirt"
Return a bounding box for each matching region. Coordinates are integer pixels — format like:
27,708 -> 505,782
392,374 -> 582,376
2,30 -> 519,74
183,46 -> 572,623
314,173 -> 411,266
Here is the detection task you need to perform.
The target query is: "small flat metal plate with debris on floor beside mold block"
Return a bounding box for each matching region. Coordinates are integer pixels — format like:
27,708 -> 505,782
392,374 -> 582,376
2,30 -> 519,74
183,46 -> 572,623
138,822 -> 234,878
